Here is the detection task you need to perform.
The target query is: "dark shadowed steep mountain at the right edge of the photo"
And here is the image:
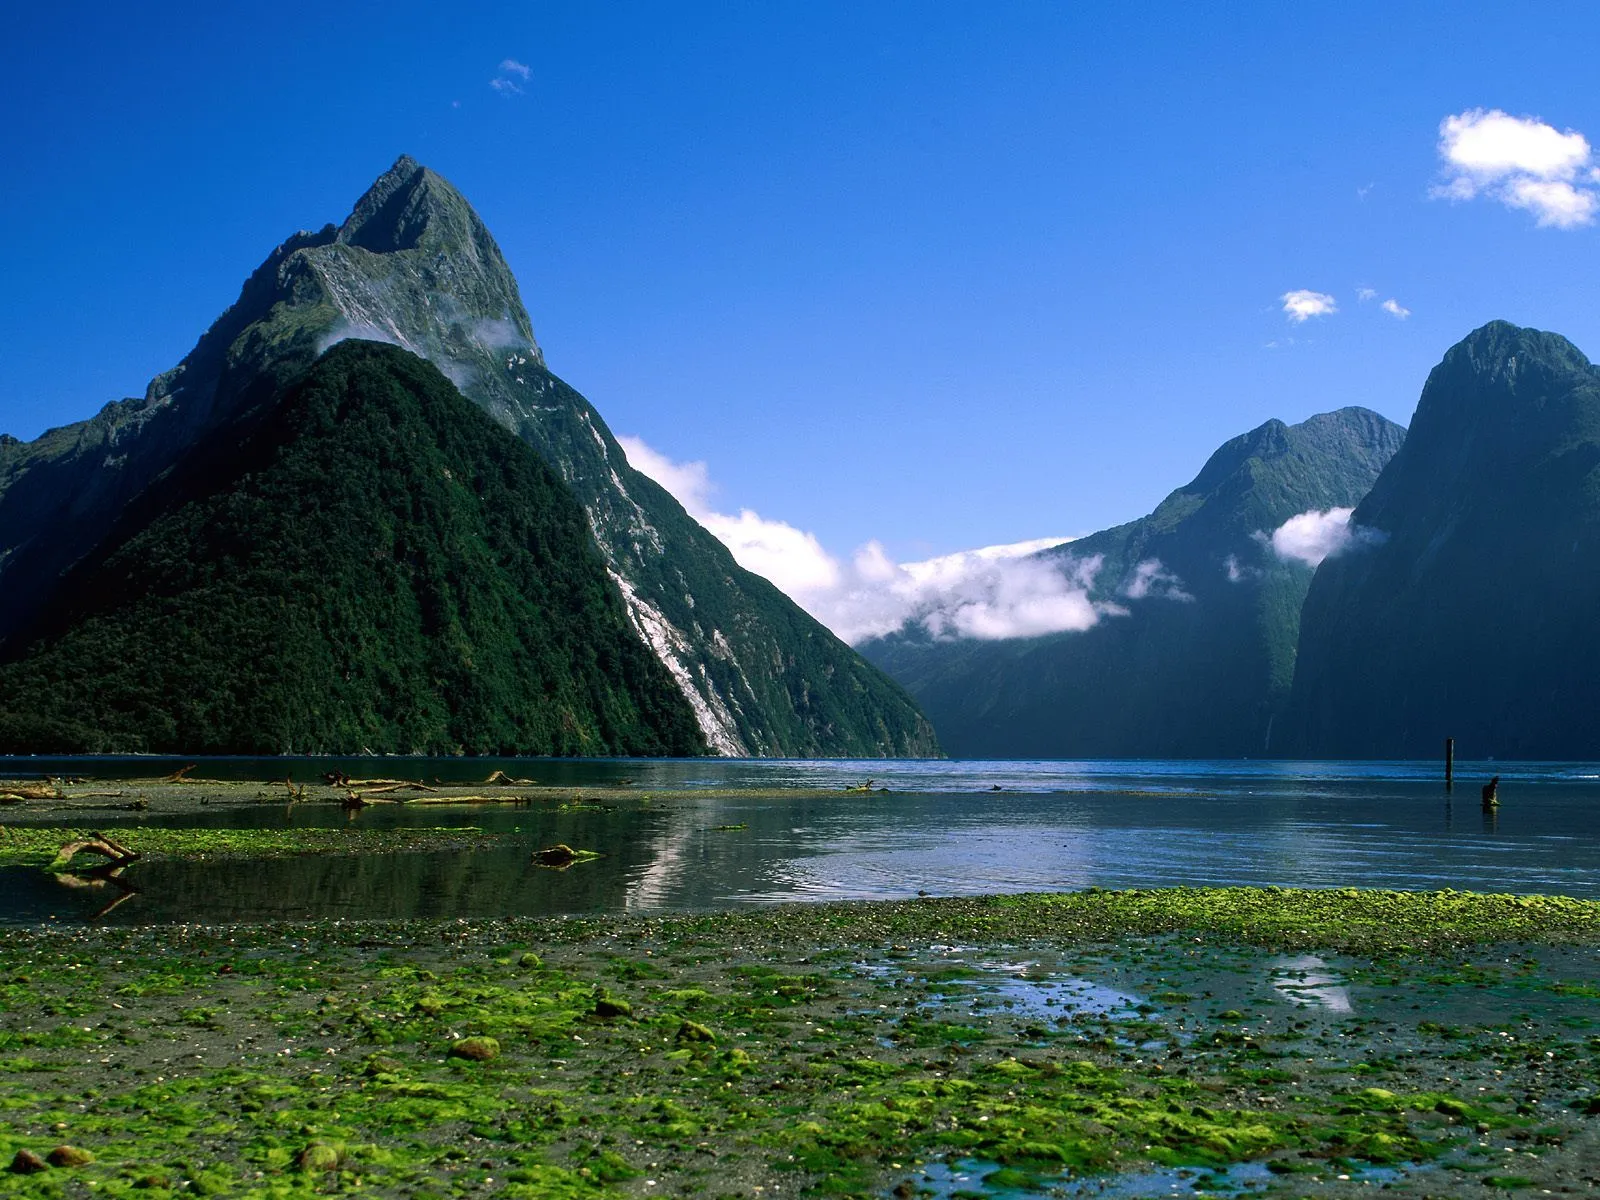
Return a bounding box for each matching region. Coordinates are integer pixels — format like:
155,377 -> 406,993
1286,322 -> 1600,758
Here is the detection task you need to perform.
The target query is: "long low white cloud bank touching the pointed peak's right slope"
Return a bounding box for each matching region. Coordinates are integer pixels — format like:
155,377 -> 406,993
618,437 -> 1107,642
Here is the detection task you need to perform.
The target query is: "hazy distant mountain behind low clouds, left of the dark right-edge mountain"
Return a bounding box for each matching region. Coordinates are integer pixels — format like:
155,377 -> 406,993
861,408 -> 1405,758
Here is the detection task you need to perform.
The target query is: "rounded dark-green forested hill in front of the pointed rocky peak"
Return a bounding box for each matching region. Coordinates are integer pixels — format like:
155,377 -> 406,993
0,342 -> 704,754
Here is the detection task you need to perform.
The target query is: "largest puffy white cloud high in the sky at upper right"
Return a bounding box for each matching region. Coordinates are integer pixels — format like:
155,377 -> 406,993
1432,109 -> 1600,229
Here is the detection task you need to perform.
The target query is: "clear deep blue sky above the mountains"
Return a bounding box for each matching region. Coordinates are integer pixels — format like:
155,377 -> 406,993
0,3 -> 1600,579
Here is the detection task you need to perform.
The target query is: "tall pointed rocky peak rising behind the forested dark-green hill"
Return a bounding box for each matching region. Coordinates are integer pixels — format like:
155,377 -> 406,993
0,158 -> 938,755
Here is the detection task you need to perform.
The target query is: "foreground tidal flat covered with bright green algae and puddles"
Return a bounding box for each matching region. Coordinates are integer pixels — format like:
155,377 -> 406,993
0,848 -> 1600,1198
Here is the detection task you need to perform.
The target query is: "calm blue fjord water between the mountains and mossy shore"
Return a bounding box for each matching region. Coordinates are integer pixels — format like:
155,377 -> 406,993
0,758 -> 1600,923
